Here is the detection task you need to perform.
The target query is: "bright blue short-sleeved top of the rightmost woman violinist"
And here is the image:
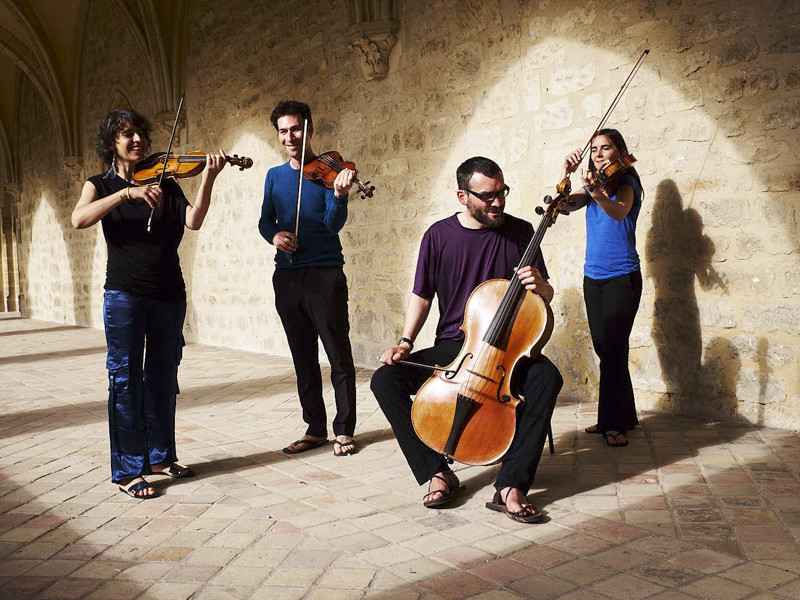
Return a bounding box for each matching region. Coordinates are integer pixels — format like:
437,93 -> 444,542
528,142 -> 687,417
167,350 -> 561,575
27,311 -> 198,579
583,174 -> 642,279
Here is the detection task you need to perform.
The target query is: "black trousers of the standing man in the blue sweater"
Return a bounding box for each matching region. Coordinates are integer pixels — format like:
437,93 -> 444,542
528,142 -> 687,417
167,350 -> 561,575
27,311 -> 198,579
272,267 -> 356,437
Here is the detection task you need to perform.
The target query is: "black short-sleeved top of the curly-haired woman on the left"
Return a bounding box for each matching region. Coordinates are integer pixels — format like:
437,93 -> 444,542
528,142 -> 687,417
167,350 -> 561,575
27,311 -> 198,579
89,175 -> 189,300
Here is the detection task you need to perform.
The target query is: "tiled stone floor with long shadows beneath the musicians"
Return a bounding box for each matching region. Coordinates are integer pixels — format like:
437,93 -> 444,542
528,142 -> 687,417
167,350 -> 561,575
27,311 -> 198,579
0,318 -> 800,600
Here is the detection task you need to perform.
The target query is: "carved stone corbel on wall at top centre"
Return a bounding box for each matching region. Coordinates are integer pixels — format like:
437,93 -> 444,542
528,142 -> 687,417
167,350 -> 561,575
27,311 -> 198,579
347,0 -> 400,81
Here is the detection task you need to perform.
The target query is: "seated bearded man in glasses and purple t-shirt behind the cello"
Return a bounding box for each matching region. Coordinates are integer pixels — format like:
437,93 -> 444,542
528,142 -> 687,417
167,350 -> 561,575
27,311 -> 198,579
371,157 -> 563,523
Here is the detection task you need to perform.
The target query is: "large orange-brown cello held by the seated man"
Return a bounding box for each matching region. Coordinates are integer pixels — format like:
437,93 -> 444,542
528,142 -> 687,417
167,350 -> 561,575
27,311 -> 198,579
406,50 -> 649,465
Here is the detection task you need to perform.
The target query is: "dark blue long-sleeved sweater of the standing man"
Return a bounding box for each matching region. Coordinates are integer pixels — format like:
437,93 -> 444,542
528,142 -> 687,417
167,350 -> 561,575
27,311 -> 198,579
258,161 -> 347,269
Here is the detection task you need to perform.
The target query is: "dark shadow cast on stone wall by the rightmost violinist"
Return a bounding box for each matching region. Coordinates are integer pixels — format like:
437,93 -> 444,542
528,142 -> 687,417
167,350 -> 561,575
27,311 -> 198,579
645,179 -> 741,415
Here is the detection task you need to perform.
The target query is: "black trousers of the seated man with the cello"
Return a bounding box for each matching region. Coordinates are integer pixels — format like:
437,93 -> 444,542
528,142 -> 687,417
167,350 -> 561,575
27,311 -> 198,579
370,340 -> 564,494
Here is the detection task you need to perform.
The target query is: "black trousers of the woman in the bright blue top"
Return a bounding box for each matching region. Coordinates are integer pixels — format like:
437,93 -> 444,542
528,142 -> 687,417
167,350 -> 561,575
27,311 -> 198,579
583,271 -> 642,433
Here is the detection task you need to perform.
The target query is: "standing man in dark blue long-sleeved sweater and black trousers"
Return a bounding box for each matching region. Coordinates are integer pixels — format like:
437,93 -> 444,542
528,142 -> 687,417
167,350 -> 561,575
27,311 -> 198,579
258,100 -> 356,456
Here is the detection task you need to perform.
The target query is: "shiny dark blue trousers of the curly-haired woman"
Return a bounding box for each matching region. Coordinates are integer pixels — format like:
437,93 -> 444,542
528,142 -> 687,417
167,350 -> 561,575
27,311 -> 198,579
103,290 -> 186,483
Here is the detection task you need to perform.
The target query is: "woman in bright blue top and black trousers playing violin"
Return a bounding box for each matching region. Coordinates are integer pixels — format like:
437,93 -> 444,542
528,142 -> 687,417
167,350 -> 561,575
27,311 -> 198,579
562,129 -> 642,447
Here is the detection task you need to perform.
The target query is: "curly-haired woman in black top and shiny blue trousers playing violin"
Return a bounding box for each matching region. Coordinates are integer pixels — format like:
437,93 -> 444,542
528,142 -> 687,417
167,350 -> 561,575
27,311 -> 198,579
72,110 -> 225,499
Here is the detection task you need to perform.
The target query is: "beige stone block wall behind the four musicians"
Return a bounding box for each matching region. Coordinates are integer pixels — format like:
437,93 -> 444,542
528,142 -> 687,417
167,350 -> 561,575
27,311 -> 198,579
14,0 -> 800,427
